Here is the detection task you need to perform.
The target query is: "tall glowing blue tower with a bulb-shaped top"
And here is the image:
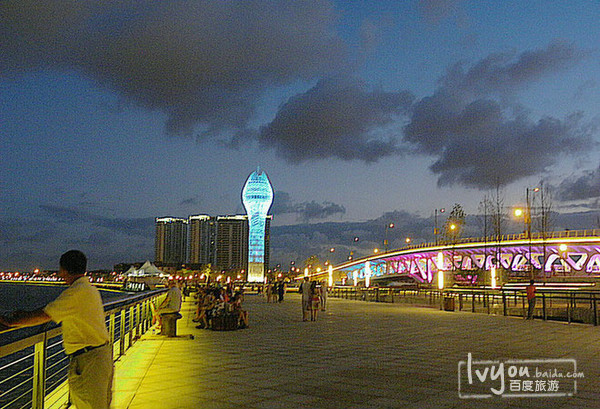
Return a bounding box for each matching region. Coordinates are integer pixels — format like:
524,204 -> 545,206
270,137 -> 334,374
242,168 -> 273,282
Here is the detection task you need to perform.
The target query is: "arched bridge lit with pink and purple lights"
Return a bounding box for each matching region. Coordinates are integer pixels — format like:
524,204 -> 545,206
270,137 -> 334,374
322,230 -> 600,286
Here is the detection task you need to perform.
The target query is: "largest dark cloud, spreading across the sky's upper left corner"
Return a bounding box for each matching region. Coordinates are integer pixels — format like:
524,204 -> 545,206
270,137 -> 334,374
0,0 -> 347,134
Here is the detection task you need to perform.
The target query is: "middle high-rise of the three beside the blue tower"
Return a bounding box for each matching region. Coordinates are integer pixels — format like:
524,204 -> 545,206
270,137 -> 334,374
188,214 -> 217,264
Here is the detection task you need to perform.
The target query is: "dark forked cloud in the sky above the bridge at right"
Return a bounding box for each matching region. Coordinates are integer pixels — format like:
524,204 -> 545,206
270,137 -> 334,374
404,43 -> 594,189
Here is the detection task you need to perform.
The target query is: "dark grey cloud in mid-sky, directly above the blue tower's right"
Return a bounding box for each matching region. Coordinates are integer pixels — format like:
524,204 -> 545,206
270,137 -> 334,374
259,78 -> 413,163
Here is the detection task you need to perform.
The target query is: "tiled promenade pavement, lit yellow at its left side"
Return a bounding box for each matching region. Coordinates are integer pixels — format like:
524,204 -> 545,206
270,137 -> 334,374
114,294 -> 600,409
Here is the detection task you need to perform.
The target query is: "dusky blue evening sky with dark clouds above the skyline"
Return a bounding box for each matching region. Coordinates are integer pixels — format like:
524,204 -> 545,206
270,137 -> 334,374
0,0 -> 600,270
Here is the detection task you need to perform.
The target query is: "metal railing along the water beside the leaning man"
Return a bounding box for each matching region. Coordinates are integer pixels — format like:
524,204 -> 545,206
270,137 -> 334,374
0,290 -> 166,409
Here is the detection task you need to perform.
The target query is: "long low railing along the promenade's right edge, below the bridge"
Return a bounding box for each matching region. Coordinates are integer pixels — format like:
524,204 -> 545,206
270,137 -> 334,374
329,287 -> 600,325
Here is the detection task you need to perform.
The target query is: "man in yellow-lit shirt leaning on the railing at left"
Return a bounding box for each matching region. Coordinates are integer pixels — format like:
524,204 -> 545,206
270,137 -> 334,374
0,250 -> 114,409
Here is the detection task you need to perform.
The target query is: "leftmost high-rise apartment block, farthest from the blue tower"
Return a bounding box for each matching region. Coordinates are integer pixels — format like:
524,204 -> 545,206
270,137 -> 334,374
154,217 -> 188,263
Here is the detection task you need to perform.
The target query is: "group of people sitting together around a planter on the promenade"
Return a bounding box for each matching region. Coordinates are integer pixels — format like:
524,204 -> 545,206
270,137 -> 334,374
192,286 -> 248,329
